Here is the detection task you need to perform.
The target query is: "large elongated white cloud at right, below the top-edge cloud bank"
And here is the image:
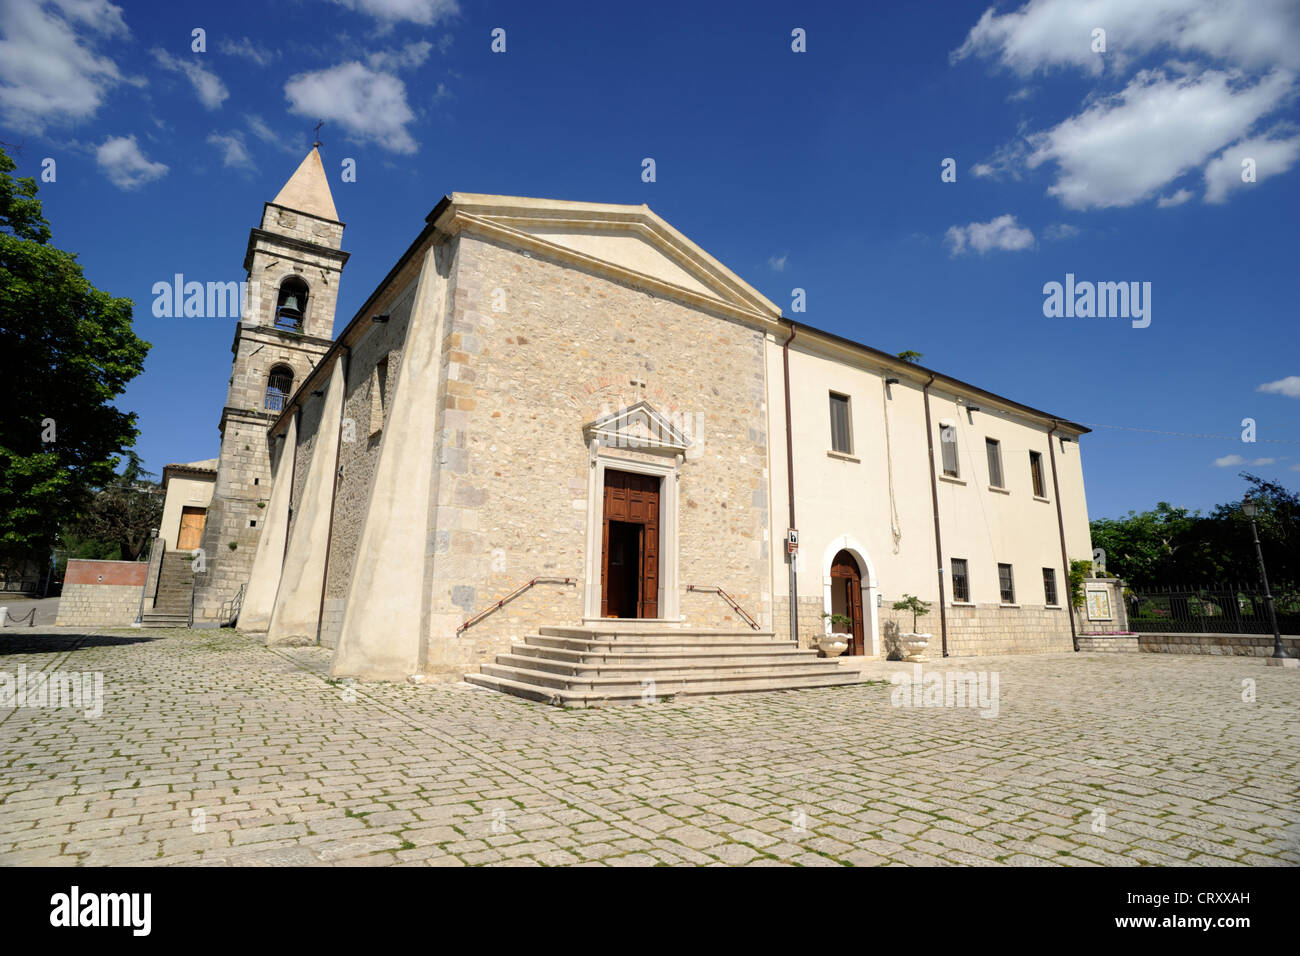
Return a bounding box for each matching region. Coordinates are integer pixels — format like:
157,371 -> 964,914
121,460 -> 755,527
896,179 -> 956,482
1027,70 -> 1292,209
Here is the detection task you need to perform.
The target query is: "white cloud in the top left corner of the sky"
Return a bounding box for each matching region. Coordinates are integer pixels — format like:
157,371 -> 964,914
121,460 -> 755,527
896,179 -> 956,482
0,0 -> 130,133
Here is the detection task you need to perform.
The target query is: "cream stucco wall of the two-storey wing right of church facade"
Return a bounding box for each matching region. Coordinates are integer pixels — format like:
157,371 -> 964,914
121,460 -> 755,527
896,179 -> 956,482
767,336 -> 1091,656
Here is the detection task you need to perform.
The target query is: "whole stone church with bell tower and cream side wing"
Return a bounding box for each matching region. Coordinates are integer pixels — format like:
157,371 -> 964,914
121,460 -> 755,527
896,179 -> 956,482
165,150 -> 1092,696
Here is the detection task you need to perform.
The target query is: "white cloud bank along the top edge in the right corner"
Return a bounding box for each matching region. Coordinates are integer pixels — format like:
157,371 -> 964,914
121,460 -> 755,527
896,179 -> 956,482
950,0 -> 1300,75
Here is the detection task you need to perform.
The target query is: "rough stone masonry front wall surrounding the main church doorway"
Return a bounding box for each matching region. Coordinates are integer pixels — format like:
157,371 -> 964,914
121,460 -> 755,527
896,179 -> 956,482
428,234 -> 771,672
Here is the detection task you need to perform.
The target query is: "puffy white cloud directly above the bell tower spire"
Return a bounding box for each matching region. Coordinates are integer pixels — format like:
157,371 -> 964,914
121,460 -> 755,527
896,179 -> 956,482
285,61 -> 420,153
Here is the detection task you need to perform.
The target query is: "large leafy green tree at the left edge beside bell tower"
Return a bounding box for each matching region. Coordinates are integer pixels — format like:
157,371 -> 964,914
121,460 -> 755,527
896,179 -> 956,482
0,148 -> 150,559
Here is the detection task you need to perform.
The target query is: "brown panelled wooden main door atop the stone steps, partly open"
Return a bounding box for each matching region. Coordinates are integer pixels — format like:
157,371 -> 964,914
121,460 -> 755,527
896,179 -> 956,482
601,470 -> 659,618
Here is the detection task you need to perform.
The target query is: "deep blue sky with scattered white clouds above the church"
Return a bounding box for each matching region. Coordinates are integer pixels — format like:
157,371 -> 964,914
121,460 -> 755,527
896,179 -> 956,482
0,0 -> 1300,518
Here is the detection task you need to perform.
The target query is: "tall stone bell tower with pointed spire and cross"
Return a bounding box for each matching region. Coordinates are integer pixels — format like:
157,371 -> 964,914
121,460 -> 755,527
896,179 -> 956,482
194,144 -> 348,623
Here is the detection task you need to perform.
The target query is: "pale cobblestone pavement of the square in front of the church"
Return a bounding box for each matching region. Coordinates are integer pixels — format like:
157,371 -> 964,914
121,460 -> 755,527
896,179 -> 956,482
0,628 -> 1300,866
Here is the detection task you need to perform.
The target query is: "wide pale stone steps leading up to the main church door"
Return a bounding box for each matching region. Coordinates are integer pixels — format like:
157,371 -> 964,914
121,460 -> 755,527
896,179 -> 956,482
465,622 -> 862,708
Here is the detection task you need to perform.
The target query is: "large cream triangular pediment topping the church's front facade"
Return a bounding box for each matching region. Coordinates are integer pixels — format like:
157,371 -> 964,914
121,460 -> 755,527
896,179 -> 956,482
438,193 -> 781,321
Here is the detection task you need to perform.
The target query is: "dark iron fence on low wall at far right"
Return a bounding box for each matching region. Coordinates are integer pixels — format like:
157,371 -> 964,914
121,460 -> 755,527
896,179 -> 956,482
1125,584 -> 1300,635
